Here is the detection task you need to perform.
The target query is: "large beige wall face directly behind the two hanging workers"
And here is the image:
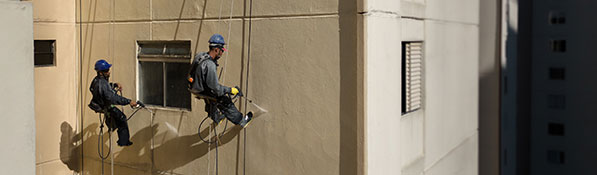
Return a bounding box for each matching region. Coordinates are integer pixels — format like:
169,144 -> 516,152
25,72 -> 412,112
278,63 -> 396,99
74,0 -> 342,174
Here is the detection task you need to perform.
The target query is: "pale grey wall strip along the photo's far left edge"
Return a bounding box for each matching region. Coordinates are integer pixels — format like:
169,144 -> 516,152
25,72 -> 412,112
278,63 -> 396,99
0,1 -> 36,174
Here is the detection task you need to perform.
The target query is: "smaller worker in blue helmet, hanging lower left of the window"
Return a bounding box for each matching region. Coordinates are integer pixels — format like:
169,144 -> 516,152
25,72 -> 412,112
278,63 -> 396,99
89,59 -> 137,146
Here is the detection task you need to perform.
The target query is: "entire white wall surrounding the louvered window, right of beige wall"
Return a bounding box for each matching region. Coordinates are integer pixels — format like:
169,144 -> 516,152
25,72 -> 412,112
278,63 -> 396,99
364,0 -> 479,174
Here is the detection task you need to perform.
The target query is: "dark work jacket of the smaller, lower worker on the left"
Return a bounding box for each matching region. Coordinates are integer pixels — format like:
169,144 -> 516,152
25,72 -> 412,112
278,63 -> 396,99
89,75 -> 131,109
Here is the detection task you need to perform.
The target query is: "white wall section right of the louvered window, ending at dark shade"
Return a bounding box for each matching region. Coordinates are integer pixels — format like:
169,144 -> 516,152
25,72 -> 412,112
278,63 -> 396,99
425,0 -> 479,174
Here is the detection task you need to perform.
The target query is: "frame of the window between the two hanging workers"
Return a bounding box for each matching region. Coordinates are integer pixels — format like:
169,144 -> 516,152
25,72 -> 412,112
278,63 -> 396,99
135,40 -> 193,111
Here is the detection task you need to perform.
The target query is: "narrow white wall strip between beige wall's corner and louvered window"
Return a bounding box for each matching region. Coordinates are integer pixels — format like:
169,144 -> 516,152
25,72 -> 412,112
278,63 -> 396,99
364,1 -> 402,175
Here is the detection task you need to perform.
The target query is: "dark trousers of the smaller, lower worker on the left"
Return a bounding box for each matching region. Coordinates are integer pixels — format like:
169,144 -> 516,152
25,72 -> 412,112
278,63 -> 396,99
106,107 -> 130,145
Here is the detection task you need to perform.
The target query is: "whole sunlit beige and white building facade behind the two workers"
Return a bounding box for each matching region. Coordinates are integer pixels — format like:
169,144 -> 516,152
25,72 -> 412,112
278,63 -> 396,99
32,0 -> 480,175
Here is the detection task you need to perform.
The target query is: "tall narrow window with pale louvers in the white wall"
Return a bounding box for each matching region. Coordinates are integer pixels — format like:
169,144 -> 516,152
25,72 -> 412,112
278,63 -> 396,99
402,41 -> 423,114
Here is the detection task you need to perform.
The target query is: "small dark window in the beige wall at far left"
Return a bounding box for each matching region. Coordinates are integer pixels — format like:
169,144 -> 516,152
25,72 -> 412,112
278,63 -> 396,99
33,40 -> 56,67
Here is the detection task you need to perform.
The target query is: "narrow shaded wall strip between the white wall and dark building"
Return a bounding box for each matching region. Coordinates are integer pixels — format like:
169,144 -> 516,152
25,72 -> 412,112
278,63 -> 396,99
479,0 -> 501,175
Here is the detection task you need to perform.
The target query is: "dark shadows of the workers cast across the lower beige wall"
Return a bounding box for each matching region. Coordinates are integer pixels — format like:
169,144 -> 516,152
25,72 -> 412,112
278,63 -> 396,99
60,119 -> 241,174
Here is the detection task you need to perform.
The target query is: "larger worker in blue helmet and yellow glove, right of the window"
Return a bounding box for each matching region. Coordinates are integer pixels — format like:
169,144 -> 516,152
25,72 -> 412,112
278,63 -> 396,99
187,34 -> 253,128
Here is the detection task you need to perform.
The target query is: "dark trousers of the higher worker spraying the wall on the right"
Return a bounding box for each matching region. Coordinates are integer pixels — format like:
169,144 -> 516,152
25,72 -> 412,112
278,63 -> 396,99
205,96 -> 243,125
